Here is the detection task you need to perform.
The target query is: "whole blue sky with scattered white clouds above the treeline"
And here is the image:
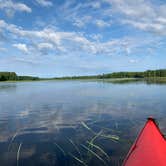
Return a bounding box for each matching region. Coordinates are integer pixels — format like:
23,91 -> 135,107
0,0 -> 166,77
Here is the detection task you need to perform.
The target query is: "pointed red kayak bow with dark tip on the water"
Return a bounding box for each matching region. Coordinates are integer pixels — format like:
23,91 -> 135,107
123,118 -> 166,166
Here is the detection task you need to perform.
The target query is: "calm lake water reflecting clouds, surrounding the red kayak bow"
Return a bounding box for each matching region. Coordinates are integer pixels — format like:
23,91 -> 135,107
0,81 -> 166,166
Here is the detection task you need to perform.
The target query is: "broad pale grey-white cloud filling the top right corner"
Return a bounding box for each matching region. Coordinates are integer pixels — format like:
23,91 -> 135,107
104,0 -> 166,35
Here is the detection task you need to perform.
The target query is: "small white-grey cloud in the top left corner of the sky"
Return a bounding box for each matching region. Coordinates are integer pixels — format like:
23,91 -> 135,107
0,0 -> 32,17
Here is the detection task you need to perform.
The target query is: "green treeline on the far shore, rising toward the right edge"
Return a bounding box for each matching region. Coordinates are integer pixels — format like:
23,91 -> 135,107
55,69 -> 166,79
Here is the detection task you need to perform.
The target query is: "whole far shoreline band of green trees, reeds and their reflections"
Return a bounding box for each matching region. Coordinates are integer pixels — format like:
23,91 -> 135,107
0,69 -> 166,83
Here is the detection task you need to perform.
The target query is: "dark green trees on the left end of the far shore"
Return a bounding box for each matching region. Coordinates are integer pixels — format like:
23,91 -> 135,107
0,72 -> 39,81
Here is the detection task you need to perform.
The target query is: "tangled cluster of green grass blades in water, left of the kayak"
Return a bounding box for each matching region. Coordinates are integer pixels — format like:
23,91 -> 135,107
51,122 -> 119,166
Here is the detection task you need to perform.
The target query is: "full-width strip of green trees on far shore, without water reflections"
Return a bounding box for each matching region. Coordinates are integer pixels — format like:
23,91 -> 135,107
0,69 -> 166,81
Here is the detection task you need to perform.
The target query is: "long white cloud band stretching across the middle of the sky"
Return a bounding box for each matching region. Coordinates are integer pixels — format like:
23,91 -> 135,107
0,20 -> 163,56
